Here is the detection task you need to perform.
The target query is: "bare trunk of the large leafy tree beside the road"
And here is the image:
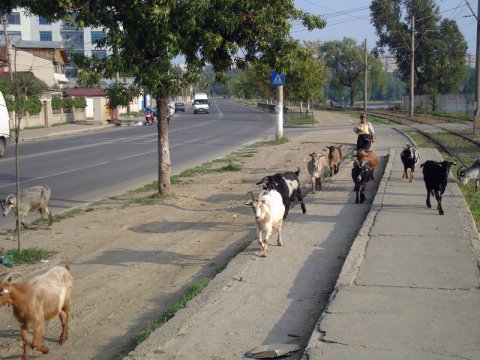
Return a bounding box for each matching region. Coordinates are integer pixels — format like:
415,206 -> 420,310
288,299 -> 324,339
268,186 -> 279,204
157,95 -> 171,196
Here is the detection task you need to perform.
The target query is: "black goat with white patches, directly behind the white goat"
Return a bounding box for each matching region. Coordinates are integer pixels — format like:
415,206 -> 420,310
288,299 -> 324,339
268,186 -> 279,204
257,169 -> 307,219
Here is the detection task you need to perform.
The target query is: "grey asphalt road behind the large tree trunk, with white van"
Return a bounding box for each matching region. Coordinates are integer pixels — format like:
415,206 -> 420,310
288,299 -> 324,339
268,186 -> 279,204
0,99 -> 275,229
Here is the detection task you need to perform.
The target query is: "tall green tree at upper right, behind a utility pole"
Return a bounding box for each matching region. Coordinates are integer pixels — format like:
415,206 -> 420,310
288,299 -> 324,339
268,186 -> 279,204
370,0 -> 467,95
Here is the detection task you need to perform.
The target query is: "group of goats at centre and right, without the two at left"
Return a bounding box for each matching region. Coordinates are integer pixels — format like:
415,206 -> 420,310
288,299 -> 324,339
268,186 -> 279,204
246,144 -> 480,257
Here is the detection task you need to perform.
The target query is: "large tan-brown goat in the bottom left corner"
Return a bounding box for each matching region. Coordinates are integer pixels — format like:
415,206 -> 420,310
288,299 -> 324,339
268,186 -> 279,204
0,265 -> 73,360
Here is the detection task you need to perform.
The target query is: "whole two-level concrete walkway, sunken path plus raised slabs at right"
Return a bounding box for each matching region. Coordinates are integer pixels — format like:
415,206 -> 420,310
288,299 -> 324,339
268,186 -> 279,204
126,122 -> 480,360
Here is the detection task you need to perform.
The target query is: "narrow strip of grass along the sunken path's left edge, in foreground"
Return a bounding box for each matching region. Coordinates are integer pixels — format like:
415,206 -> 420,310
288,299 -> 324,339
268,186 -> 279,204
124,277 -> 210,355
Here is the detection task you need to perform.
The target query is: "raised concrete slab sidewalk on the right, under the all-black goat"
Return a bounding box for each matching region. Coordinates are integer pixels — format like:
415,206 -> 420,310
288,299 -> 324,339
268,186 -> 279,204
305,145 -> 480,360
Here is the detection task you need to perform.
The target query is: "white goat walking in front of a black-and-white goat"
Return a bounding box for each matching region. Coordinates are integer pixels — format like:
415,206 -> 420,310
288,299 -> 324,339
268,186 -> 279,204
247,190 -> 285,257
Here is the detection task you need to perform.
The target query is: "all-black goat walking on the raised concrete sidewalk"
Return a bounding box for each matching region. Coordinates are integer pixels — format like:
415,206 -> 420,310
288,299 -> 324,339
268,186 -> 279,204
420,160 -> 455,215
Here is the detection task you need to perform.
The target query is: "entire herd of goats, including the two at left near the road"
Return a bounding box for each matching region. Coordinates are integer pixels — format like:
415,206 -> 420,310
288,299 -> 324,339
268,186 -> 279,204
0,145 -> 480,360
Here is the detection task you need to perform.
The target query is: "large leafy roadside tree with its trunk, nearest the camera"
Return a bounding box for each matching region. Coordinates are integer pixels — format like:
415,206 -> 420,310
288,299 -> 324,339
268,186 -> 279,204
8,0 -> 325,195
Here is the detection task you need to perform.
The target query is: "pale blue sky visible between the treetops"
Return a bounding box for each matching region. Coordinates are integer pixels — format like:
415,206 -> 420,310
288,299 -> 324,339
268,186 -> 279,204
291,0 -> 478,54
